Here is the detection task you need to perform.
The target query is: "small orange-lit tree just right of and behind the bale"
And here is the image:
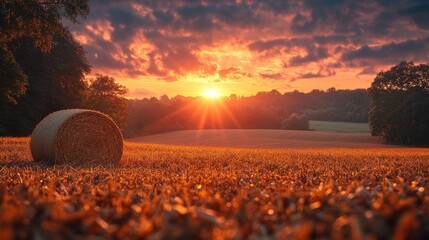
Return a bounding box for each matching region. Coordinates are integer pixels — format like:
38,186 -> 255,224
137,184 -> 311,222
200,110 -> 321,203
83,75 -> 128,129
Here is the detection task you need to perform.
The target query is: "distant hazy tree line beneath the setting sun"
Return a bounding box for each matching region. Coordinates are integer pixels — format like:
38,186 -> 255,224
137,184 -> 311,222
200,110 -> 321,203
124,88 -> 370,137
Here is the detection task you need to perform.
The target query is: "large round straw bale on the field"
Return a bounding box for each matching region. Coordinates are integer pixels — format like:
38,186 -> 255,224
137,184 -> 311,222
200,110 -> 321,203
30,109 -> 123,164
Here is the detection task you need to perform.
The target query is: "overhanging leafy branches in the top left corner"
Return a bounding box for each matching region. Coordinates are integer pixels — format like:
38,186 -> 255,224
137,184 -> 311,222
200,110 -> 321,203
0,0 -> 89,105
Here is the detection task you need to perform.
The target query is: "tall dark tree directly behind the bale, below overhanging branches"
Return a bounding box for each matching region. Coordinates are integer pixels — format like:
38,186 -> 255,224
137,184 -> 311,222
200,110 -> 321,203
0,34 -> 90,136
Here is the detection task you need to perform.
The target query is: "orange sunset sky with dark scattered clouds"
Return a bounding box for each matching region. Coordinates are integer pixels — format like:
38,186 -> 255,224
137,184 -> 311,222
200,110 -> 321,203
67,0 -> 429,98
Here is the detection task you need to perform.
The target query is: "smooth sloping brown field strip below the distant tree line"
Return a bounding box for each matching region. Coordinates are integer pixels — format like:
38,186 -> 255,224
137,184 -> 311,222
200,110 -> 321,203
129,129 -> 399,148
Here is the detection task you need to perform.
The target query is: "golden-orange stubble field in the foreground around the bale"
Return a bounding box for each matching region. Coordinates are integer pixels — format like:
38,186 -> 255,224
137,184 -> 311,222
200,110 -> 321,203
0,138 -> 429,239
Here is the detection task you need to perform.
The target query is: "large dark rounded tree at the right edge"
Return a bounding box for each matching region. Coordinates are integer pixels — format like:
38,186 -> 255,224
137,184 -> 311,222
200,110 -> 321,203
369,62 -> 429,144
